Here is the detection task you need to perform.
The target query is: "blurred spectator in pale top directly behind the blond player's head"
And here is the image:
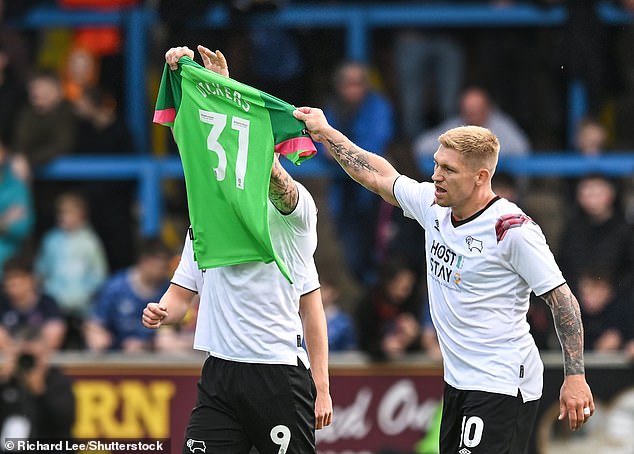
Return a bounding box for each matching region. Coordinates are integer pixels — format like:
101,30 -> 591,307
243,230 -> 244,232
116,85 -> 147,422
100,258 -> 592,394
414,87 -> 531,159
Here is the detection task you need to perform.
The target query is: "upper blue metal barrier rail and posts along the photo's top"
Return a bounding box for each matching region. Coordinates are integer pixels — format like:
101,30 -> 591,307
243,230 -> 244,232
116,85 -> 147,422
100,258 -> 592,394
9,1 -> 634,153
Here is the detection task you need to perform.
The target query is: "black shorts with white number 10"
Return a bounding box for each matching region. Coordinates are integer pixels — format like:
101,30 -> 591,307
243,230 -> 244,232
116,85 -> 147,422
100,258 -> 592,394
440,383 -> 539,454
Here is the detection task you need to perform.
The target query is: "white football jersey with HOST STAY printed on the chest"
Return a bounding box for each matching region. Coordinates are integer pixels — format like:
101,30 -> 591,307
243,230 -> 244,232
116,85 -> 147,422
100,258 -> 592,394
394,176 -> 565,401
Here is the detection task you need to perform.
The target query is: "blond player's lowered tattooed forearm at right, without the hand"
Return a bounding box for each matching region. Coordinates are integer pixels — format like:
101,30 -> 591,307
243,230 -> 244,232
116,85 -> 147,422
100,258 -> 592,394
542,284 -> 584,375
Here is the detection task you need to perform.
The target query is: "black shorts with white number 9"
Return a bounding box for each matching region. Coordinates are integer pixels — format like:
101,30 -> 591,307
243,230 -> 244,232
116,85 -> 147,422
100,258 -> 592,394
183,356 -> 316,454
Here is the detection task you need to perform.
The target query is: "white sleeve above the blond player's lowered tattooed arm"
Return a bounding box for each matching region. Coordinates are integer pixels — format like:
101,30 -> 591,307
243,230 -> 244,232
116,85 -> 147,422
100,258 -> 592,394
498,218 -> 566,296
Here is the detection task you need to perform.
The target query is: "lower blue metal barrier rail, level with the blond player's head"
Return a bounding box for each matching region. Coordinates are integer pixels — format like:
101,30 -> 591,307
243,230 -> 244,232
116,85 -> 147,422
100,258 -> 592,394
36,152 -> 634,236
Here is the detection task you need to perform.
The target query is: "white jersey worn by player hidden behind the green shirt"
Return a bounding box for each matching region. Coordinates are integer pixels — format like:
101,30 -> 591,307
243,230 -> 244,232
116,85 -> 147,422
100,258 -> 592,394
172,183 -> 319,367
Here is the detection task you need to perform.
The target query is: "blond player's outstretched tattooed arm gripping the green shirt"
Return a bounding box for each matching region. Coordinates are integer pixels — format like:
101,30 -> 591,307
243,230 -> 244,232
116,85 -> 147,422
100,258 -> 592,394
293,107 -> 399,206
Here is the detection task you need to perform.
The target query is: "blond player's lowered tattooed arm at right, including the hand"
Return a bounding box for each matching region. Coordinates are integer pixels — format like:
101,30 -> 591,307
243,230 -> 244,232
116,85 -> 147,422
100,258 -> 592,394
542,284 -> 594,430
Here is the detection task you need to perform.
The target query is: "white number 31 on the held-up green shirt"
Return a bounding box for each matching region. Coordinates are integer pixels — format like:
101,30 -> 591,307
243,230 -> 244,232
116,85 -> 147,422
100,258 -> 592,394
198,109 -> 250,189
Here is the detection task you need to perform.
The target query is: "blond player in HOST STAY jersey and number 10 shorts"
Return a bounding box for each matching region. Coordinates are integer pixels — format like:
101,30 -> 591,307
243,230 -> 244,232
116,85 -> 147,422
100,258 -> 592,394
294,107 -> 594,454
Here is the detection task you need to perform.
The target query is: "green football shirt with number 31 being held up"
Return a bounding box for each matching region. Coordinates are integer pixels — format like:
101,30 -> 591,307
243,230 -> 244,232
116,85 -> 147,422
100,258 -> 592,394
154,57 -> 316,281
